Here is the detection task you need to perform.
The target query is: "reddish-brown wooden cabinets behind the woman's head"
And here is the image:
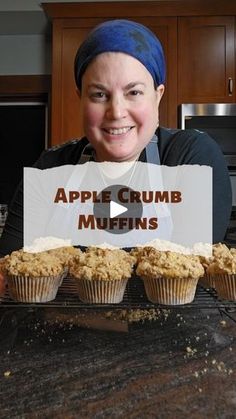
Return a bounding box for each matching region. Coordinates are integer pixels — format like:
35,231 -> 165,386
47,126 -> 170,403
43,0 -> 236,144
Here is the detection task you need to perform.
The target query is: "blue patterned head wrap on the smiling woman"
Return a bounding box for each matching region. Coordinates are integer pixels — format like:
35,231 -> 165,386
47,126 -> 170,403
74,19 -> 165,90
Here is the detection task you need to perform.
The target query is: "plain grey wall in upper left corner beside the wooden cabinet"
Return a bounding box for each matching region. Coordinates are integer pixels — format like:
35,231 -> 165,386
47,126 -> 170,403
0,0 -> 173,75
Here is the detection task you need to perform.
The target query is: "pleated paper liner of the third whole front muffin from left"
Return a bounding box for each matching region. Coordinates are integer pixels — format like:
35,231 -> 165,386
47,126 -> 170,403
143,277 -> 198,305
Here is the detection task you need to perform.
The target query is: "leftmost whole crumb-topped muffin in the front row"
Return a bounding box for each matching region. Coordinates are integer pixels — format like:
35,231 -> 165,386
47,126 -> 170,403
5,250 -> 63,303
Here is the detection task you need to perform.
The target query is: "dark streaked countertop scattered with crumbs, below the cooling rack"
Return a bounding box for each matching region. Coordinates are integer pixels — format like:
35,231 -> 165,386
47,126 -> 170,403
0,307 -> 236,419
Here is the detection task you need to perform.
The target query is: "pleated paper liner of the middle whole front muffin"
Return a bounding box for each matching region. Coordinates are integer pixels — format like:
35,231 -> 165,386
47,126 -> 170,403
75,278 -> 128,304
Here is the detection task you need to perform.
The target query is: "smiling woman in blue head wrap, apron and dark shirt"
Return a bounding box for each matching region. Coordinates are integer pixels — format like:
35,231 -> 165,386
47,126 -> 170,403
0,20 -> 231,255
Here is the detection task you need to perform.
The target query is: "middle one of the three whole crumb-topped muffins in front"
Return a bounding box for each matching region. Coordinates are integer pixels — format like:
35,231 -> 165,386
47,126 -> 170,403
69,247 -> 134,304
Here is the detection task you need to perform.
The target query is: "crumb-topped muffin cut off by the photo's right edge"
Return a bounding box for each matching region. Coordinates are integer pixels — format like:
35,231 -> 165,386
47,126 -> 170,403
207,249 -> 236,301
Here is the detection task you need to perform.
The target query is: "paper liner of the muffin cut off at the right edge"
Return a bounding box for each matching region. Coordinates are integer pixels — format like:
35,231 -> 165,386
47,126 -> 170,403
215,274 -> 236,301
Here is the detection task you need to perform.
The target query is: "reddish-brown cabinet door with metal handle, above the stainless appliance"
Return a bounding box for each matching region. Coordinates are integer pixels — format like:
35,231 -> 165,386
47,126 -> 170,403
178,16 -> 236,104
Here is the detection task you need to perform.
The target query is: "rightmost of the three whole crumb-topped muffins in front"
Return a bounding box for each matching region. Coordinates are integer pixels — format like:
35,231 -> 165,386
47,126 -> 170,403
136,249 -> 204,305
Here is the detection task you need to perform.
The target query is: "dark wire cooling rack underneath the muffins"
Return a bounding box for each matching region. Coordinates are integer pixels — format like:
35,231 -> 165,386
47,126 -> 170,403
0,277 -> 236,312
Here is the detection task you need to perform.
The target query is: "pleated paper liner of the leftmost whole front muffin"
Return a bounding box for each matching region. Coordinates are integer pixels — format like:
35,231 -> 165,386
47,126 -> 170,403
8,275 -> 61,303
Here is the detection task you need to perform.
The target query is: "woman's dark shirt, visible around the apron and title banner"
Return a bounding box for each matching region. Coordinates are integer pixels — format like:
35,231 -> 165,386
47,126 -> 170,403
0,127 -> 232,256
